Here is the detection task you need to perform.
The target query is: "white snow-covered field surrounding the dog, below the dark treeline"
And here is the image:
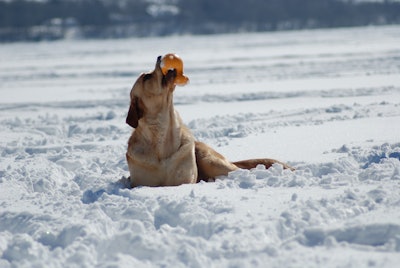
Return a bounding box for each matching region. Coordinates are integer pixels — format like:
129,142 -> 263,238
0,26 -> 400,268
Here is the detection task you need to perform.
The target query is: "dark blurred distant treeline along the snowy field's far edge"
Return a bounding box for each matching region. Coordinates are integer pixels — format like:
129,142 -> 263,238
0,0 -> 400,41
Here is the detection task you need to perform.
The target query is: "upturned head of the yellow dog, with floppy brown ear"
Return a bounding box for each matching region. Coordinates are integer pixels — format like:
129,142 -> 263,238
126,56 -> 176,128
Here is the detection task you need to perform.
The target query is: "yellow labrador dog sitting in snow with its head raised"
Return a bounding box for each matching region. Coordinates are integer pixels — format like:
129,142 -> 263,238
126,57 -> 290,187
